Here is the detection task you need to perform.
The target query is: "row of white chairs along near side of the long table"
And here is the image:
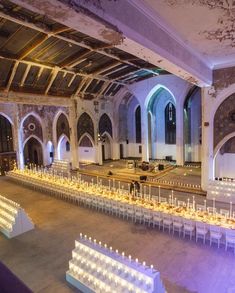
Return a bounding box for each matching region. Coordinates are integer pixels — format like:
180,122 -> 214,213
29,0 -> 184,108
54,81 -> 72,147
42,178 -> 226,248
8,172 -> 235,253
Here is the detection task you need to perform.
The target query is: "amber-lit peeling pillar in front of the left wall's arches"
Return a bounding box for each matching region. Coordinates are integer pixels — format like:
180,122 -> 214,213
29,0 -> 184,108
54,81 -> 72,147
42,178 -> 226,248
68,101 -> 79,169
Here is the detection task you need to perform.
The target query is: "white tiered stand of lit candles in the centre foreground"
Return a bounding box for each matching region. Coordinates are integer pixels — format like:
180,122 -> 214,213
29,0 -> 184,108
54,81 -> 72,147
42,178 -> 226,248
68,233 -> 159,293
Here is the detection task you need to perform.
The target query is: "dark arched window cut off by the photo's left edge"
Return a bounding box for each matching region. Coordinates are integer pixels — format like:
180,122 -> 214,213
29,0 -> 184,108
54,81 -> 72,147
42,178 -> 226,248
0,115 -> 13,153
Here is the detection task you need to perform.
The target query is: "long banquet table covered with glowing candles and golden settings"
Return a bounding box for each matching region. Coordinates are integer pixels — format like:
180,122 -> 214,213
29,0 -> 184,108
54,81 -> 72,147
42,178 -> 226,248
7,169 -> 235,242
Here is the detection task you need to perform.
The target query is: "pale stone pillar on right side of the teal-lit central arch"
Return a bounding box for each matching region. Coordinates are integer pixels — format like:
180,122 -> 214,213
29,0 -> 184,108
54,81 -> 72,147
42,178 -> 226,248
176,101 -> 184,166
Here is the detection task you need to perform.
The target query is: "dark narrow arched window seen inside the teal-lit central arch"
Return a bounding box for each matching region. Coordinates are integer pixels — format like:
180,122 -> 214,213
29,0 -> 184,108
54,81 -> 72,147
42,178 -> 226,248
165,102 -> 176,144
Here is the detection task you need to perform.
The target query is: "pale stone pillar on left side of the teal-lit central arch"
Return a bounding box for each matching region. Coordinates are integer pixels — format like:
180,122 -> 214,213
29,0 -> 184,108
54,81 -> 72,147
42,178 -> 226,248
141,105 -> 149,162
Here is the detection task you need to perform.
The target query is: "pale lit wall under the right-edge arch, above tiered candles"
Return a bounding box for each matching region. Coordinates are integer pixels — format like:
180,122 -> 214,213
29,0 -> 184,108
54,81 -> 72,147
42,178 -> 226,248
215,152 -> 235,178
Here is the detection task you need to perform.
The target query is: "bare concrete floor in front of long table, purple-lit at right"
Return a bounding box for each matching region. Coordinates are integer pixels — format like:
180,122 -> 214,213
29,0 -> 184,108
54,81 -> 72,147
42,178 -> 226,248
0,178 -> 235,293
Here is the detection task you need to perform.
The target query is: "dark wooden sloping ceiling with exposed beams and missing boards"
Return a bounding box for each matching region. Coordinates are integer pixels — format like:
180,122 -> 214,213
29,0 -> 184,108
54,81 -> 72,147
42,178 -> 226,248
0,0 -> 169,99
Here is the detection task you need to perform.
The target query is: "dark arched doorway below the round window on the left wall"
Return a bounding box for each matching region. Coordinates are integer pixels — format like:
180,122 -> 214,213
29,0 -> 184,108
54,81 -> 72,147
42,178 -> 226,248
24,137 -> 43,166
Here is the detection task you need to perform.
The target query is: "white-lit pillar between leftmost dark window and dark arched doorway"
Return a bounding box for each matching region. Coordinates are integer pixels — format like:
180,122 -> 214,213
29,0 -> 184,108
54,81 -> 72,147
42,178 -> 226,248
13,105 -> 24,169
